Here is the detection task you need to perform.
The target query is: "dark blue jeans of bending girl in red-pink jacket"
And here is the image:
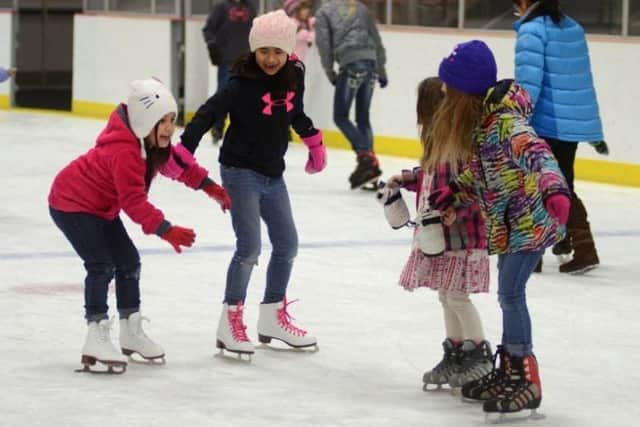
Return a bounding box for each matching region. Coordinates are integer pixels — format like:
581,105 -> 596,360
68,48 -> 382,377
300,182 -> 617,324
49,208 -> 140,322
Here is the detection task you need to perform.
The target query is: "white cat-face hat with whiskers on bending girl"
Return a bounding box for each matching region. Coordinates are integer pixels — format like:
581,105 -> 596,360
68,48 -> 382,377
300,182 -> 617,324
127,78 -> 178,139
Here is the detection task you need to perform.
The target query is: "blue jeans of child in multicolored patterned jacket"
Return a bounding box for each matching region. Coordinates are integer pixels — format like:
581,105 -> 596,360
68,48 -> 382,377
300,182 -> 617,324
498,250 -> 544,357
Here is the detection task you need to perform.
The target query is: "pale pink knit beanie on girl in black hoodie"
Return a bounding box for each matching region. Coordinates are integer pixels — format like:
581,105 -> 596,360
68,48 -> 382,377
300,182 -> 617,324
249,9 -> 298,54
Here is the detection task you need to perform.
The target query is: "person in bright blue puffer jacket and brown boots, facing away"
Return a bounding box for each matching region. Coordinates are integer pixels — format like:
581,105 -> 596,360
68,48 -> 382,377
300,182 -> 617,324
513,0 -> 608,274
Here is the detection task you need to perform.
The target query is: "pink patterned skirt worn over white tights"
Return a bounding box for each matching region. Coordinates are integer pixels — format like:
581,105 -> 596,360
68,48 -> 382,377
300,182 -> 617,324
400,248 -> 489,293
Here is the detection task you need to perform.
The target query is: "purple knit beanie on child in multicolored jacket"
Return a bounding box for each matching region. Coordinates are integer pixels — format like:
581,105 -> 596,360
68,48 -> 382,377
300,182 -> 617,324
438,40 -> 498,96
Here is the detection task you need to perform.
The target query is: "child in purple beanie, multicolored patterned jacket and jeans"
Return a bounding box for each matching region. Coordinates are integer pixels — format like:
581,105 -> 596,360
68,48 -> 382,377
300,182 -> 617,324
429,40 -> 570,413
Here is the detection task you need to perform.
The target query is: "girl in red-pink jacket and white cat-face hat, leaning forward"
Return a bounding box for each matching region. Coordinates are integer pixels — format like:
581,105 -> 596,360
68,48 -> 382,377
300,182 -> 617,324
49,79 -> 231,373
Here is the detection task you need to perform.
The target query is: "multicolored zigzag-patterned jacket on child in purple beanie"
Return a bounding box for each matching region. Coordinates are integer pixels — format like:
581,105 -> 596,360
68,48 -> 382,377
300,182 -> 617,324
450,80 -> 570,254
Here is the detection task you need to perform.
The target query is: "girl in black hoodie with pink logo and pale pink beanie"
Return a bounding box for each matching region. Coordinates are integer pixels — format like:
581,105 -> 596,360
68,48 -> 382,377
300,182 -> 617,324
182,10 -> 326,356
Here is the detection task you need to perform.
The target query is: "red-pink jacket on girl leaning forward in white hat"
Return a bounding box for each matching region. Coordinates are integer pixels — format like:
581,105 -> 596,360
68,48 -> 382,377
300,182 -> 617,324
49,104 -> 208,234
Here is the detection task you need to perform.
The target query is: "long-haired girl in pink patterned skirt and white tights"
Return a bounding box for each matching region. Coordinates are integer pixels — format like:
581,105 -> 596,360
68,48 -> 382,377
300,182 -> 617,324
388,77 -> 492,390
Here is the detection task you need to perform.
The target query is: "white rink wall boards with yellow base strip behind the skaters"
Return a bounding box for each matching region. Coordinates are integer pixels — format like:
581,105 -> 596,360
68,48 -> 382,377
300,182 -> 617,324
61,15 -> 640,186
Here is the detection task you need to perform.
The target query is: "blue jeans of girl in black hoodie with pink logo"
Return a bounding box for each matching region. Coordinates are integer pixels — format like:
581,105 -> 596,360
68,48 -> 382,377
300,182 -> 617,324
220,165 -> 298,305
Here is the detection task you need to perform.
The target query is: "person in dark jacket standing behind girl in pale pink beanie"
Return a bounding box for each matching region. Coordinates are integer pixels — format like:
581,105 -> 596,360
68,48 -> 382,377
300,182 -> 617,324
202,0 -> 256,144
